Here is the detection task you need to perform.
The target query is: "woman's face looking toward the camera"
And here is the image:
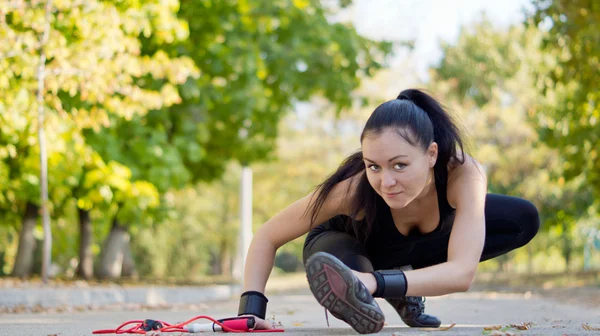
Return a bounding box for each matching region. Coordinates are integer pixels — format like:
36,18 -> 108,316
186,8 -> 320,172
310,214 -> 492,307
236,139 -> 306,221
362,128 -> 437,209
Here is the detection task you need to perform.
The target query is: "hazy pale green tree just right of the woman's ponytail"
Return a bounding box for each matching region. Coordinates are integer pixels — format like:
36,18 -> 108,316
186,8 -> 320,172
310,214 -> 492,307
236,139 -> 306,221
431,18 -> 592,267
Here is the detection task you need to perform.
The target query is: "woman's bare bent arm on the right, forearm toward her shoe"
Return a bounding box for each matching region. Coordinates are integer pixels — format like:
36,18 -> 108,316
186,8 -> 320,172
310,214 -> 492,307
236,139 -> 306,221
405,156 -> 487,296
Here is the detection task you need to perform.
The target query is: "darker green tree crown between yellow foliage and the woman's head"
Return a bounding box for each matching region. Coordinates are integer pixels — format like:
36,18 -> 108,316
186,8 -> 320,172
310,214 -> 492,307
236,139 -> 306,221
86,0 -> 391,278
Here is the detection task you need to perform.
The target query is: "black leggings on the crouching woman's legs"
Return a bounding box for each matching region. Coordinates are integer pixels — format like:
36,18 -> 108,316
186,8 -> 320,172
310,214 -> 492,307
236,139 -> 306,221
303,194 -> 540,272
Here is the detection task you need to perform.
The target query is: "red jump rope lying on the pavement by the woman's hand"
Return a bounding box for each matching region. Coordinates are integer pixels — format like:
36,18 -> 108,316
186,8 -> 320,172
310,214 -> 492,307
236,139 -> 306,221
92,315 -> 285,334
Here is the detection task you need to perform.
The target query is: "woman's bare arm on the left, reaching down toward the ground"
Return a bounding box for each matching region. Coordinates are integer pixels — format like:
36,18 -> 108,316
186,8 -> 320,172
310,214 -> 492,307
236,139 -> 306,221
243,178 -> 354,293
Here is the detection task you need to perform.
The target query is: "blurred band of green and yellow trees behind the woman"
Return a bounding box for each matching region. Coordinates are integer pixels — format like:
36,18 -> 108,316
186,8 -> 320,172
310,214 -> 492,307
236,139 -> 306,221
0,0 -> 600,281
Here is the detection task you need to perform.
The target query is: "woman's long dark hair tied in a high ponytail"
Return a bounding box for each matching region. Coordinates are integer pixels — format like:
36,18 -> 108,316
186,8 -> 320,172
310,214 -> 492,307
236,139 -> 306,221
307,89 -> 464,240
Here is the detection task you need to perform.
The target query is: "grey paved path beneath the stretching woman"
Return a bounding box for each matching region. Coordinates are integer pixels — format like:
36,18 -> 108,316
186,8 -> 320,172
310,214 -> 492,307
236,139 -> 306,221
0,289 -> 600,336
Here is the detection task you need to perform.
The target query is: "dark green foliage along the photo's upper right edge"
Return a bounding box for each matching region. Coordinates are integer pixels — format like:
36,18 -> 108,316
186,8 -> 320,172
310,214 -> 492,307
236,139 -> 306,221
531,0 -> 600,206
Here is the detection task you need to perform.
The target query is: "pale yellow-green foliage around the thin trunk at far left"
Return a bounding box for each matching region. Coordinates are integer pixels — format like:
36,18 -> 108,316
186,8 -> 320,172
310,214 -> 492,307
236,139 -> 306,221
0,0 -> 193,223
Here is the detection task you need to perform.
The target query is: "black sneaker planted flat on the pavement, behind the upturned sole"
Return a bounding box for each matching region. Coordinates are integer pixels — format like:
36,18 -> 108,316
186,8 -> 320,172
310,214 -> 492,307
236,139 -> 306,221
386,296 -> 442,328
